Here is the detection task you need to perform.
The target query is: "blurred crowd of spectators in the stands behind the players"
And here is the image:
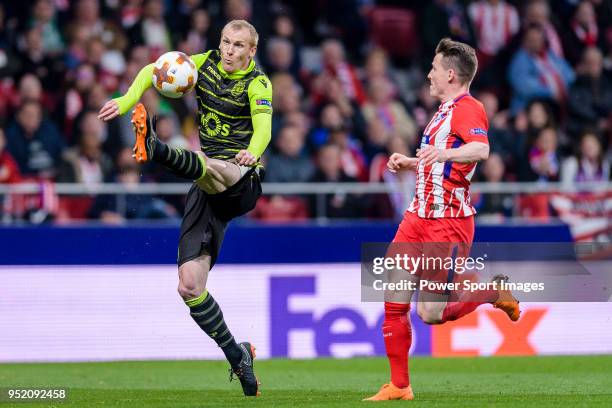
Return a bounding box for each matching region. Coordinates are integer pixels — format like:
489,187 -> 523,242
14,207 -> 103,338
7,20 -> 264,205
0,0 -> 612,222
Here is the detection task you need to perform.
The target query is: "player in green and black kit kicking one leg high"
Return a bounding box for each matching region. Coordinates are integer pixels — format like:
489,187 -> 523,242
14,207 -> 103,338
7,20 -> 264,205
98,20 -> 272,396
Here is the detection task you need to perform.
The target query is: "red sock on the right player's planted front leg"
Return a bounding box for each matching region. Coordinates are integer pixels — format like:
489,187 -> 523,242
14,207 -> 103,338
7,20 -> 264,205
383,302 -> 412,388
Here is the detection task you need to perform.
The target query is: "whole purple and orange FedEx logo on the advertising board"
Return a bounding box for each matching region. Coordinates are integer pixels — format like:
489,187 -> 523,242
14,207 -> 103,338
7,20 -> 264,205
269,276 -> 548,357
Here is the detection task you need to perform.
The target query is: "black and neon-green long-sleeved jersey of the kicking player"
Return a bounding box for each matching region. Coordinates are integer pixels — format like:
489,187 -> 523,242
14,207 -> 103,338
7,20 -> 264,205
116,50 -> 272,160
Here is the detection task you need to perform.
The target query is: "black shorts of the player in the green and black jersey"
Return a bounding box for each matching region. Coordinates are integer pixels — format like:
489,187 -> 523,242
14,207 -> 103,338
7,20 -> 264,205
177,169 -> 263,268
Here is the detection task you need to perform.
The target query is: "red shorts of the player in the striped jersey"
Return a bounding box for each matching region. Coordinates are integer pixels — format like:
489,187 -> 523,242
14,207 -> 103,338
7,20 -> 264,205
387,211 -> 474,293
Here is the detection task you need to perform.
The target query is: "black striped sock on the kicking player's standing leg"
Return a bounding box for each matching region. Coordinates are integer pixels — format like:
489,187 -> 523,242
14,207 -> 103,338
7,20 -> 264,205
185,291 -> 242,367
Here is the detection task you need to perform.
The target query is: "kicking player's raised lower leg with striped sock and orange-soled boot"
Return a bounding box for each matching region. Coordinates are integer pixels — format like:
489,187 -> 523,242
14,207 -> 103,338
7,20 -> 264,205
132,103 -> 206,180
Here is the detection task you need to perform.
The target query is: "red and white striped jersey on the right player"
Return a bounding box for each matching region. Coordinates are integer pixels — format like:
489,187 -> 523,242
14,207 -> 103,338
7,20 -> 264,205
408,94 -> 489,218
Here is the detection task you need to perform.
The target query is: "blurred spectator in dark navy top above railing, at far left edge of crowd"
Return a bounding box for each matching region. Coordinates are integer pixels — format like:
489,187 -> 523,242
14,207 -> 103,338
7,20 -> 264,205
6,101 -> 64,179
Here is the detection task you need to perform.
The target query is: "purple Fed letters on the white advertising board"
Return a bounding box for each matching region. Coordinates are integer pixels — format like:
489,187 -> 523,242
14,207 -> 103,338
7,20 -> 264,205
270,276 -> 431,357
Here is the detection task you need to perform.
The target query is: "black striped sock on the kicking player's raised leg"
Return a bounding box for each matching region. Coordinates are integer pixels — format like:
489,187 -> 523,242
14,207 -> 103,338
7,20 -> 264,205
153,140 -> 206,180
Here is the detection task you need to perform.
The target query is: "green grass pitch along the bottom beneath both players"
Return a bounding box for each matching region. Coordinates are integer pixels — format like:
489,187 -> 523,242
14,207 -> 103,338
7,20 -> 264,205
0,356 -> 612,408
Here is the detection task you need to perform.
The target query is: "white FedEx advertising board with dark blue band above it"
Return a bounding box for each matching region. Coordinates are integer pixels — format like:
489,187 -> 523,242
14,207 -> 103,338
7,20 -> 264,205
0,222 -> 612,362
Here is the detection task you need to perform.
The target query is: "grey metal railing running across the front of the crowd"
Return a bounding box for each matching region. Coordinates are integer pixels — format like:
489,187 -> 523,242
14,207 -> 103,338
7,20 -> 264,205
0,180 -> 612,221
